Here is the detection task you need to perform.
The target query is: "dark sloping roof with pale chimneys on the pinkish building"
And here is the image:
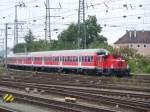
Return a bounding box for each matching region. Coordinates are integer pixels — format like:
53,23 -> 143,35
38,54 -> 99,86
114,31 -> 150,44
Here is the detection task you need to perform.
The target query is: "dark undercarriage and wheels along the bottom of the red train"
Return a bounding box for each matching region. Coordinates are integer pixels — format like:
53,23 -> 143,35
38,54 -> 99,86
8,65 -> 130,77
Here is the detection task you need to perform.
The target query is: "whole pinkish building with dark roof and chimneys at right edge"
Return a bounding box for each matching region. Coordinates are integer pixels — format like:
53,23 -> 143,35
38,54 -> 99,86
114,31 -> 150,56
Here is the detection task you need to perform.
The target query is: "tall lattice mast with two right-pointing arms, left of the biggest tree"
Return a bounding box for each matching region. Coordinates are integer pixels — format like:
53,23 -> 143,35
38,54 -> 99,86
45,0 -> 61,41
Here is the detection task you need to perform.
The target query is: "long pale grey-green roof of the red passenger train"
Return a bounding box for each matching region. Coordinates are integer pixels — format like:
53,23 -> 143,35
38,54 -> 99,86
8,49 -> 108,57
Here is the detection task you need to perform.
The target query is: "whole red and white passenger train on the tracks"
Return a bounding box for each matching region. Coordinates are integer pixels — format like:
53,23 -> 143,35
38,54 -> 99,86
8,49 -> 129,75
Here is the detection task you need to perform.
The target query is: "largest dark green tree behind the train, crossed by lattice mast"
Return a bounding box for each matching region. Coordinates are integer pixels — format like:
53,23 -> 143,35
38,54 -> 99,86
55,16 -> 107,49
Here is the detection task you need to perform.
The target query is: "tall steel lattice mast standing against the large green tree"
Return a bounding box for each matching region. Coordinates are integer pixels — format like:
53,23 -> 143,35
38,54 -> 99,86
78,0 -> 87,49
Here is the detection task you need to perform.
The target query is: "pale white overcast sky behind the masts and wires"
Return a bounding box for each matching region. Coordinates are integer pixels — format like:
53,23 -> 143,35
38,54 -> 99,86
0,0 -> 150,46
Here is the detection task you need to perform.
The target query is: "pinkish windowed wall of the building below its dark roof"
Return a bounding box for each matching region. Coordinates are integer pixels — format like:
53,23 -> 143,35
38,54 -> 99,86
114,43 -> 150,56
